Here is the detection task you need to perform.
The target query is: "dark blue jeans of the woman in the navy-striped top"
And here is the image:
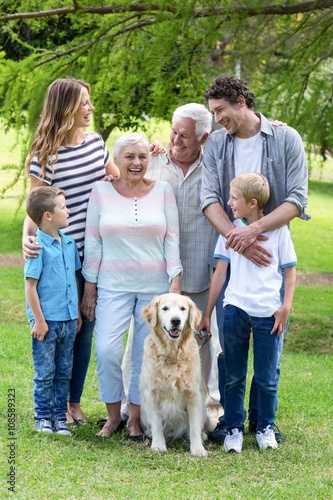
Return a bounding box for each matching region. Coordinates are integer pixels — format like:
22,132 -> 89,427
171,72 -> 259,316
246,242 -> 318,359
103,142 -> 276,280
68,272 -> 95,403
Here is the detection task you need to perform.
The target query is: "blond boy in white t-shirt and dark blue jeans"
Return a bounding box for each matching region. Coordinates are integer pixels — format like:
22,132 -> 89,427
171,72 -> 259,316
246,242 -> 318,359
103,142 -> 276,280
198,173 -> 297,453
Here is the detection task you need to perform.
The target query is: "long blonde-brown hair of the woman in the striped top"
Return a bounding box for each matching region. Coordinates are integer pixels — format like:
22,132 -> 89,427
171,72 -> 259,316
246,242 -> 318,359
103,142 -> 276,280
26,77 -> 90,179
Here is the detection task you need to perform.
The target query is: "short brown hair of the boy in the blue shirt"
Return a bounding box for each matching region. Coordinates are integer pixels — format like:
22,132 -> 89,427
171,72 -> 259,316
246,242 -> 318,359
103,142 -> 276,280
25,186 -> 66,226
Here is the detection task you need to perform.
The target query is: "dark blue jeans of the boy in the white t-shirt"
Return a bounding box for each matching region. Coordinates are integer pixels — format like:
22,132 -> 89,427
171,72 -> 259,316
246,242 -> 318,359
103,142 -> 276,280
223,305 -> 282,431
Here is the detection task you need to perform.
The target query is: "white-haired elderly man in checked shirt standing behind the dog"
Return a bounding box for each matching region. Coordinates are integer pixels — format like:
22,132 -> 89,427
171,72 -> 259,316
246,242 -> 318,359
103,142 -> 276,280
123,103 -> 222,430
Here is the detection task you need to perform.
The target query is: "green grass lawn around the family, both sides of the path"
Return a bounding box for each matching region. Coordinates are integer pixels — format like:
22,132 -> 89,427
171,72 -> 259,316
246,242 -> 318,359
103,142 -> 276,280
0,126 -> 333,500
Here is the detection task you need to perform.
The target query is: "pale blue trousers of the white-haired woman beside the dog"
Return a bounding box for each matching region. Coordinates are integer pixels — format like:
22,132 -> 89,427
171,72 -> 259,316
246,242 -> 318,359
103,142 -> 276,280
95,289 -> 156,405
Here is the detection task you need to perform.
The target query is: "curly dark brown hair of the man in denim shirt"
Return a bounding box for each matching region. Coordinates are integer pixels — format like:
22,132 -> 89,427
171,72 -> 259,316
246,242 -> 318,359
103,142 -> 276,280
204,75 -> 256,109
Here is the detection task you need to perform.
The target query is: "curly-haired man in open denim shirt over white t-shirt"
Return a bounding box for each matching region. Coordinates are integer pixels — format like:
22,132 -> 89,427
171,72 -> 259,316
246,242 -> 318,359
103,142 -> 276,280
201,76 -> 309,442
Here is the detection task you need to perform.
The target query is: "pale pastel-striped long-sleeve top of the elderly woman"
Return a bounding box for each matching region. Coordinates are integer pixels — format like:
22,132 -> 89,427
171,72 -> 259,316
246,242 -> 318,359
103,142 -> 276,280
82,181 -> 182,294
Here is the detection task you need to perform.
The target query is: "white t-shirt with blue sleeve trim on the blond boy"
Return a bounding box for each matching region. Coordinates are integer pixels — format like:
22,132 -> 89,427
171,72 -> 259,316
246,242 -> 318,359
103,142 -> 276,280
214,219 -> 297,318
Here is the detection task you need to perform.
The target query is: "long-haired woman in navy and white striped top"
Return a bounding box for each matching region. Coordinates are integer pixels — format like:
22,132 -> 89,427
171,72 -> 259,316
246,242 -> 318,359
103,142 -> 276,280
23,77 -> 119,425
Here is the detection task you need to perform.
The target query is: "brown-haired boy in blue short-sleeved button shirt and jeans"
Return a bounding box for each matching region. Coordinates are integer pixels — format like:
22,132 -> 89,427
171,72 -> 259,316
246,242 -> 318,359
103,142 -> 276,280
24,186 -> 81,436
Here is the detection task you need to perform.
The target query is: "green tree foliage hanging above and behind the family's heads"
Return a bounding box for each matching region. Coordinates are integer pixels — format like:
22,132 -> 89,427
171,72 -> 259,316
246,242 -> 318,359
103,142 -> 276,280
0,0 -> 333,155
